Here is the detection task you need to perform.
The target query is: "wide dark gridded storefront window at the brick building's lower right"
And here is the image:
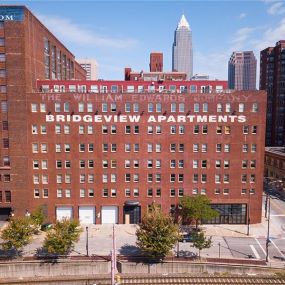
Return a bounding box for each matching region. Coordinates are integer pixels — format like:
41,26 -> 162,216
203,204 -> 247,224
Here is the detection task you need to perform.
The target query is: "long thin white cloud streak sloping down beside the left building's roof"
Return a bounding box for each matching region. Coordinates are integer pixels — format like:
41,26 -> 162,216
38,15 -> 138,48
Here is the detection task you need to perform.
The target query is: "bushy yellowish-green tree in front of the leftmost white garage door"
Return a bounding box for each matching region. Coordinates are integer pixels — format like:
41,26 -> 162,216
43,219 -> 82,255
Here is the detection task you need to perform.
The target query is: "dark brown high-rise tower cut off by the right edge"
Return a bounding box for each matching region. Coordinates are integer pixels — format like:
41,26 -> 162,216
259,40 -> 285,146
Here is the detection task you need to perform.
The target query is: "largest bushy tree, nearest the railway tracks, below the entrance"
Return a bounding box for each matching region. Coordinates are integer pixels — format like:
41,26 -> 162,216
136,205 -> 179,259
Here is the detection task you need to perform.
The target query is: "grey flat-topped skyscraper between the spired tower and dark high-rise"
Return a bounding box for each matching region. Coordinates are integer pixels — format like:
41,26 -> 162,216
228,51 -> 256,90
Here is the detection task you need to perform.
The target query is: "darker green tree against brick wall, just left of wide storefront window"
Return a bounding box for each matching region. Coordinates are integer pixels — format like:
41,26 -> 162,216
180,195 -> 219,229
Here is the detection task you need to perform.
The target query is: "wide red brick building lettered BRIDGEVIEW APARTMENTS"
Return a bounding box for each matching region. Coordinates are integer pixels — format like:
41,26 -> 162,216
31,81 -> 266,223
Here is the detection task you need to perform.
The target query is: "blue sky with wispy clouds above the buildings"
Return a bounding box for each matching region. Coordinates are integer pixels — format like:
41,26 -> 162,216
1,0 -> 285,79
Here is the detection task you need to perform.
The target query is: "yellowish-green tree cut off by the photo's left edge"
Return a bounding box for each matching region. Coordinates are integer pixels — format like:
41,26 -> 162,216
1,217 -> 33,252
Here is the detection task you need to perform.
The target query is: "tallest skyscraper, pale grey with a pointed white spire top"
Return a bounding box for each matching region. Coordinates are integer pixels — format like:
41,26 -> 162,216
172,15 -> 193,79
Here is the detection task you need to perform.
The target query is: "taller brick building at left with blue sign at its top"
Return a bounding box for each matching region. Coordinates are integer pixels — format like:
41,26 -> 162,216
0,6 -> 85,218
